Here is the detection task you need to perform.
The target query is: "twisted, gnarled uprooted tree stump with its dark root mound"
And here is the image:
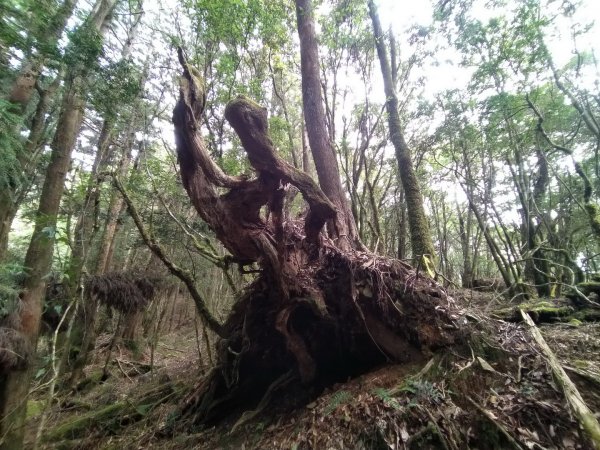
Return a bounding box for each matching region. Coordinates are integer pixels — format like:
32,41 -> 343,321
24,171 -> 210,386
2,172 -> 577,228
173,50 -> 461,422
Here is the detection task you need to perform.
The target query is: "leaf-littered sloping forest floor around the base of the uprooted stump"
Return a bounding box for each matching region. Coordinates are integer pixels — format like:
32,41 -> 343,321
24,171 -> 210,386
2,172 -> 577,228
28,290 -> 600,449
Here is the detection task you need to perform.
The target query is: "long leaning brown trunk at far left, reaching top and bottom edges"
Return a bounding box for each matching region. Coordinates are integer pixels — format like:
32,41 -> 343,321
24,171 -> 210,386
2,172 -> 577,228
0,0 -> 114,449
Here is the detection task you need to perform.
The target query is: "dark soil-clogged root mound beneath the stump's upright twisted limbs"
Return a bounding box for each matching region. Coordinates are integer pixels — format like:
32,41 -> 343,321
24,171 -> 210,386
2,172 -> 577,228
173,248 -> 462,423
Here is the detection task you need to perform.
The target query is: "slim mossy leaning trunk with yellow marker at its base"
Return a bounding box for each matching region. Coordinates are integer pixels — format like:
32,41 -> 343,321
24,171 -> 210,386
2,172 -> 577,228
369,0 -> 435,258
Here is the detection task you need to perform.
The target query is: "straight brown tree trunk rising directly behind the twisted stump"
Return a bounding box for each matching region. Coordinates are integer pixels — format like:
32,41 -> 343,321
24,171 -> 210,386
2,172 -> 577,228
296,0 -> 361,247
